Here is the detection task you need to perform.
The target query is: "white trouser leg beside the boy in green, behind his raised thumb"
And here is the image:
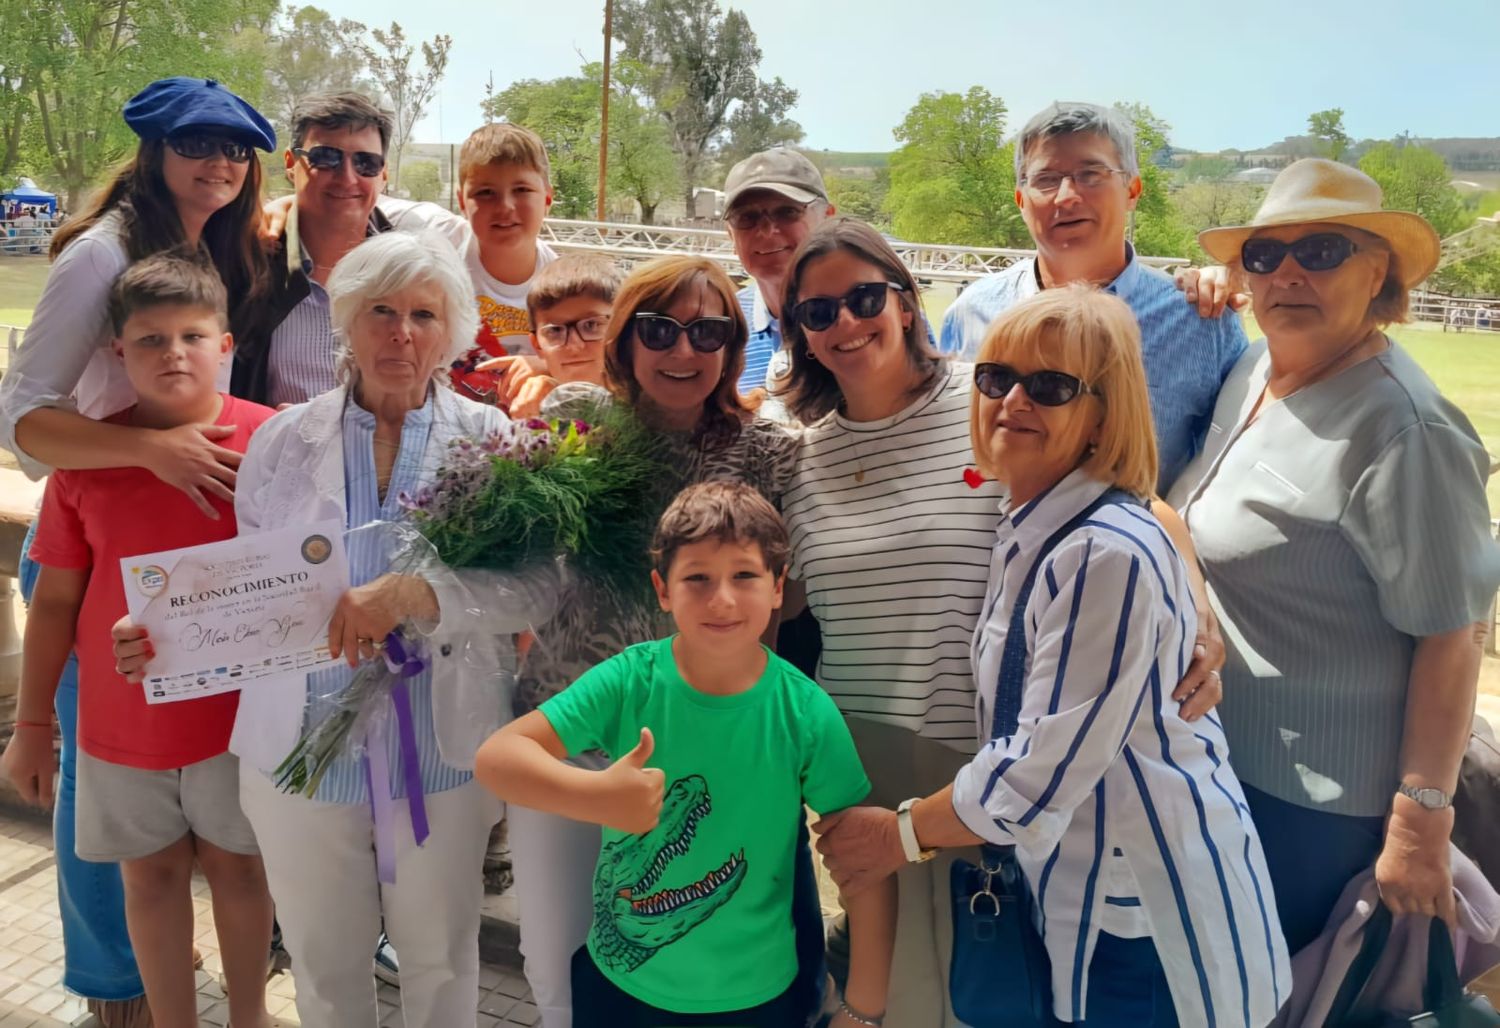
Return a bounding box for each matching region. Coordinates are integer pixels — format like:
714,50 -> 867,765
504,804 -> 600,1028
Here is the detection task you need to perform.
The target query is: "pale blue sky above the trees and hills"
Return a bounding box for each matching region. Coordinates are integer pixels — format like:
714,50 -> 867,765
325,0 -> 1500,150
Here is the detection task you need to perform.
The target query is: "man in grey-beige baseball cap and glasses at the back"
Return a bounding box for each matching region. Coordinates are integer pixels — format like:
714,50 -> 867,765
725,147 -> 834,393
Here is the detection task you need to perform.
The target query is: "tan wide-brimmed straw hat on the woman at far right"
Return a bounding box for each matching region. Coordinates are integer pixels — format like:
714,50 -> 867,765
1199,158 -> 1442,290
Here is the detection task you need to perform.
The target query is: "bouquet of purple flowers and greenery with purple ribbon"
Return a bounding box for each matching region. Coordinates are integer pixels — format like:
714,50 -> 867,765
275,401 -> 677,818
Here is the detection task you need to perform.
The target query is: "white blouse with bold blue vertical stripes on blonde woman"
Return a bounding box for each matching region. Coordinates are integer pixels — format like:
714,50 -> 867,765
953,471 -> 1292,1028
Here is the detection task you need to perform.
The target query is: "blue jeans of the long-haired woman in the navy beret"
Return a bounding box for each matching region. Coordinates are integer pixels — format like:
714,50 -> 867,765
21,525 -> 146,999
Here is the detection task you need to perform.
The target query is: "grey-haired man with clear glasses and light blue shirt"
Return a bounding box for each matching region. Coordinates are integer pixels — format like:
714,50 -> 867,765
939,104 -> 1247,494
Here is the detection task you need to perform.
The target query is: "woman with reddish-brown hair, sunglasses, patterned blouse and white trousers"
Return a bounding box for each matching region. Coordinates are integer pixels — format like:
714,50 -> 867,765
507,257 -> 822,1028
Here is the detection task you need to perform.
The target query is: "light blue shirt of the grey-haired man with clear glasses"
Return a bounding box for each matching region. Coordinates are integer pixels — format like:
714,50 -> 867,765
939,243 -> 1248,495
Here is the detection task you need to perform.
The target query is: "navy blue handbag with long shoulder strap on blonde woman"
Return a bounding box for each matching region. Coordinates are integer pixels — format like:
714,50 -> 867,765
948,489 -> 1140,1028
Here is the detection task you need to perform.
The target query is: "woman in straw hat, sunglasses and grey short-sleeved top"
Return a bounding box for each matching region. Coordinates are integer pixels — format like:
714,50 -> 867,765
1172,159 -> 1500,951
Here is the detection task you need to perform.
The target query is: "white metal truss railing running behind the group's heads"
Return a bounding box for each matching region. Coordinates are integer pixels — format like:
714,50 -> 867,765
542,218 -> 1188,282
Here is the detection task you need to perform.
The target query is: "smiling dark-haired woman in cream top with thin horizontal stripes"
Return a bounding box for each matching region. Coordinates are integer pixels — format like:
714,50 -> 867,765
782,218 -> 1001,1028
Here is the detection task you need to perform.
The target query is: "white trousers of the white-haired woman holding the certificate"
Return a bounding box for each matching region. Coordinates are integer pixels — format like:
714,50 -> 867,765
240,767 -> 503,1028
